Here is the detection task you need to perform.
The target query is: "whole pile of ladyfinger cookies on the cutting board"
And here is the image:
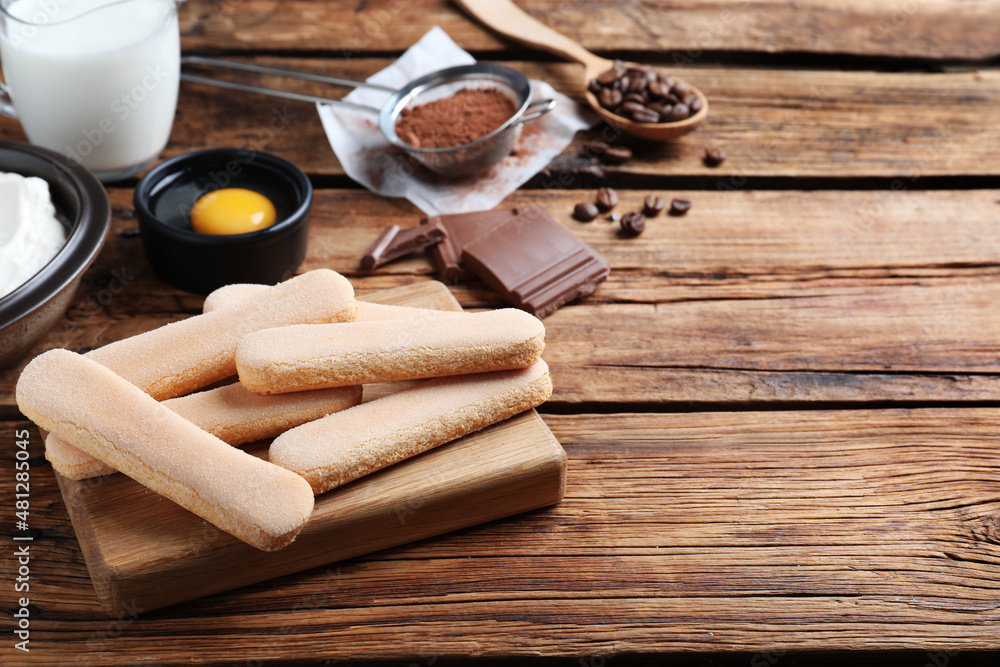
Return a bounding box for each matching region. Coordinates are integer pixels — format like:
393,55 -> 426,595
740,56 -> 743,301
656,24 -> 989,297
17,269 -> 552,551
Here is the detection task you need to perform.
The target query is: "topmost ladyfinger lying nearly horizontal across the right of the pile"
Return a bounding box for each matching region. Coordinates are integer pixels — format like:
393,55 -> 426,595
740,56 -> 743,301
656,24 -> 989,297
236,308 -> 545,394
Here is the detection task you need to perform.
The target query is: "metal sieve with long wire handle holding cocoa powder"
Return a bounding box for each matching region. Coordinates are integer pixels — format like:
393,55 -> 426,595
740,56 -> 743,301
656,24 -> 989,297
181,56 -> 556,177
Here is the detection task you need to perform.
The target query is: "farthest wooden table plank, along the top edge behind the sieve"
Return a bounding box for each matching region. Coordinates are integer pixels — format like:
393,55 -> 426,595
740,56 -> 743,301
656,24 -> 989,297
180,0 -> 1000,62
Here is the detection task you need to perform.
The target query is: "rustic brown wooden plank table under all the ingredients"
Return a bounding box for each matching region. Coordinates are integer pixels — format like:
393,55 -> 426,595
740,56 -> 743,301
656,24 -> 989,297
0,0 -> 1000,667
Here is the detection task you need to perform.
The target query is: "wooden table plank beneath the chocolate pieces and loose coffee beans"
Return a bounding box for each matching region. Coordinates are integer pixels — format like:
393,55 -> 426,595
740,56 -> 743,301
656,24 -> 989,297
7,189 -> 1000,414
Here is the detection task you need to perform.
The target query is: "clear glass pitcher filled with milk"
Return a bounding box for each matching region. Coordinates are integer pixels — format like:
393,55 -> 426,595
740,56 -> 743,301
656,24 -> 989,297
0,0 -> 181,181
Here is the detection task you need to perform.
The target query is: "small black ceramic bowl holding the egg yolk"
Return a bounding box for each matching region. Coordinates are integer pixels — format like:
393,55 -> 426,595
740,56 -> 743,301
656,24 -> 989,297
134,148 -> 312,294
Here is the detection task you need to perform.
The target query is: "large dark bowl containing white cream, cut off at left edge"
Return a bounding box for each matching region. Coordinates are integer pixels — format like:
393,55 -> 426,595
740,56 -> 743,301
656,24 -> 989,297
0,141 -> 111,368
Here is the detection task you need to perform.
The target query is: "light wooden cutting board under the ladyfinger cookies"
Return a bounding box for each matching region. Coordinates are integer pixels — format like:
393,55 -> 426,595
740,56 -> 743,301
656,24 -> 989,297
57,283 -> 566,617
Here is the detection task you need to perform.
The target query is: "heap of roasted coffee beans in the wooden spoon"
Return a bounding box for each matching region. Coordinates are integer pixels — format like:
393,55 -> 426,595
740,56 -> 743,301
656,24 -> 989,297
587,60 -> 702,123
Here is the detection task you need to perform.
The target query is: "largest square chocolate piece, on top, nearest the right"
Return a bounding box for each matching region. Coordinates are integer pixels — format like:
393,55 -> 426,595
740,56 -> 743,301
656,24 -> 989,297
462,206 -> 611,317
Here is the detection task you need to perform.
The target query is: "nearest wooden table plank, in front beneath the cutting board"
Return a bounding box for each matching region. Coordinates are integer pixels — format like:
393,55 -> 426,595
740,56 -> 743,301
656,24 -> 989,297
7,409 -> 1000,664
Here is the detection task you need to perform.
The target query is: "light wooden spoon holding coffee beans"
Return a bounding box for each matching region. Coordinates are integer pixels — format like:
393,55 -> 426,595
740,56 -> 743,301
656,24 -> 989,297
456,0 -> 708,141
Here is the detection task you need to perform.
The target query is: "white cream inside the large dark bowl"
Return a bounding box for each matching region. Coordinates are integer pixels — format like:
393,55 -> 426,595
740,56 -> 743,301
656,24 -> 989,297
0,173 -> 66,297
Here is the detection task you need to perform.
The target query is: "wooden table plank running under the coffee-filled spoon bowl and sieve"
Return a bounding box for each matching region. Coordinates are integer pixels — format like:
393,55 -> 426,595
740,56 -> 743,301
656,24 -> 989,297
0,57 -> 1000,180
